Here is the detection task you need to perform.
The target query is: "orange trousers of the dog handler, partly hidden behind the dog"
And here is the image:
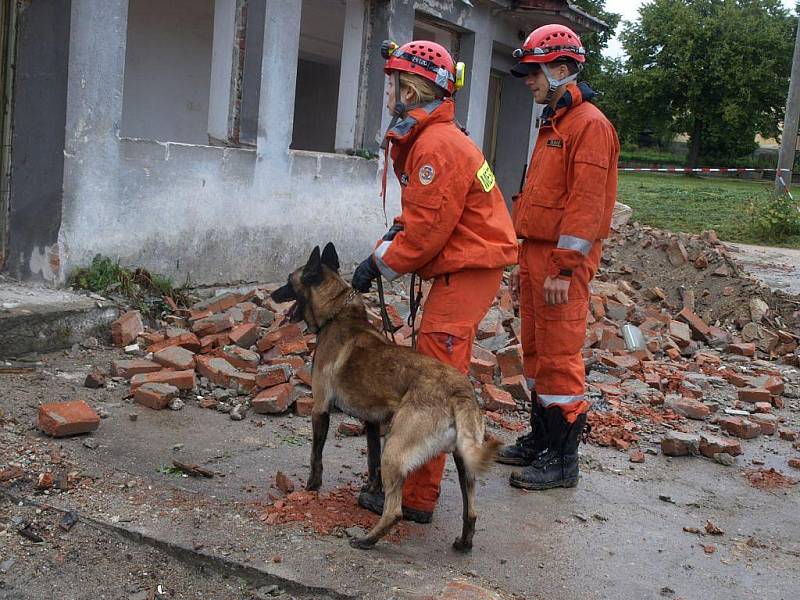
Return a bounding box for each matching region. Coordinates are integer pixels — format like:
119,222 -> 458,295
403,269 -> 503,512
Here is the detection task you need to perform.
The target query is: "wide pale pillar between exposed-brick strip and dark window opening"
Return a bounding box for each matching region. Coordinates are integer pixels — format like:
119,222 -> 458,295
254,0 -> 302,194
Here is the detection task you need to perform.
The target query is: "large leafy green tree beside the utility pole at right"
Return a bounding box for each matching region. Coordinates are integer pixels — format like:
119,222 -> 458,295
620,0 -> 795,167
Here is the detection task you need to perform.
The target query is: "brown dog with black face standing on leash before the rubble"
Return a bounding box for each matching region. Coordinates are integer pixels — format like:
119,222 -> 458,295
272,244 -> 500,552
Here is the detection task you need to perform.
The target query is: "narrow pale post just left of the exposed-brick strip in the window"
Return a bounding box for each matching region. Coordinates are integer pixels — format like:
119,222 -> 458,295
208,0 -> 236,142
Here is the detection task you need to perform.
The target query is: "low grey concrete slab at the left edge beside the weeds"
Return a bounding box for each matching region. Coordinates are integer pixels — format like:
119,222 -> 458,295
0,276 -> 118,358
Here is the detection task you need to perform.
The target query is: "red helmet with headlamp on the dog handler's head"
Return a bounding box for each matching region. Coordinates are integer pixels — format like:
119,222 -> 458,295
381,40 -> 464,96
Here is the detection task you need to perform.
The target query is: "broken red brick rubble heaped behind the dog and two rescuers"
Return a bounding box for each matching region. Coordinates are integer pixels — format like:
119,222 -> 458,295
78,223 -> 800,494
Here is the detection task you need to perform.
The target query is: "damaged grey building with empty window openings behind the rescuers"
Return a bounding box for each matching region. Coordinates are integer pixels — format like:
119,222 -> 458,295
0,0 -> 603,284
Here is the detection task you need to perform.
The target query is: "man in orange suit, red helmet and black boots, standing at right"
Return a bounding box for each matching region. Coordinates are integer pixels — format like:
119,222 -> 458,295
497,25 -> 619,490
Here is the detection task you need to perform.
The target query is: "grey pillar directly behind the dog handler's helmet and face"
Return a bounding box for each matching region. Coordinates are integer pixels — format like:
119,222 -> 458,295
361,0 -> 414,152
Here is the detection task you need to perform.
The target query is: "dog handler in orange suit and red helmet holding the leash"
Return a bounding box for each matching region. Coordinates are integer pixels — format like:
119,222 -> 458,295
352,41 -> 517,523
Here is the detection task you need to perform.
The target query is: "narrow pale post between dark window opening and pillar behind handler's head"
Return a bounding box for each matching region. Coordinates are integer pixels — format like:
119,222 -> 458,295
335,0 -> 365,152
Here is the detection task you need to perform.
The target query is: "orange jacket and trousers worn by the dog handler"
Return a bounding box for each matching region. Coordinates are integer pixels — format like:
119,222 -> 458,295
374,99 -> 517,512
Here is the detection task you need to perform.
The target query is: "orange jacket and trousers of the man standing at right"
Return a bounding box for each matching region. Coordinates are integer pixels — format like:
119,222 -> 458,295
512,83 -> 619,423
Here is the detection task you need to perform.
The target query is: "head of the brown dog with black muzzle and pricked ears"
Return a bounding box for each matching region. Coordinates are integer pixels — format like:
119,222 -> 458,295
270,242 -> 347,332
